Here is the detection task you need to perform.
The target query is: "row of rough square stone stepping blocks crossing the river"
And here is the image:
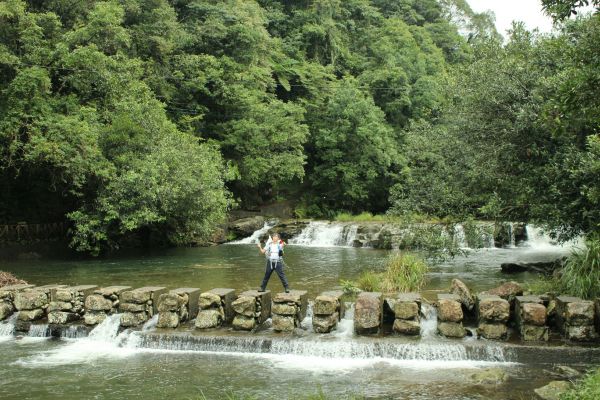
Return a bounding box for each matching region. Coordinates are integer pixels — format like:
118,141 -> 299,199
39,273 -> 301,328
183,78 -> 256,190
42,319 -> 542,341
0,285 -> 600,345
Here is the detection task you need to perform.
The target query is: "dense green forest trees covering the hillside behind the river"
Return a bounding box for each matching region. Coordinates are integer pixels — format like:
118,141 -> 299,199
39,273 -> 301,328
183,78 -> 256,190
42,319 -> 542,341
0,0 -> 600,253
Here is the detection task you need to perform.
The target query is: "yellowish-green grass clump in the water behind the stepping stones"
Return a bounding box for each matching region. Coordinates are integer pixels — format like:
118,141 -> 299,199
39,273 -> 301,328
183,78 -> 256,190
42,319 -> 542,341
341,253 -> 429,294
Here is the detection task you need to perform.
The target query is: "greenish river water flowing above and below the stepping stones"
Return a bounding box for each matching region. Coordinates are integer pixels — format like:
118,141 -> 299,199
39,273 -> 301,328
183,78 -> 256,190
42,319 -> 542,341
0,224 -> 588,400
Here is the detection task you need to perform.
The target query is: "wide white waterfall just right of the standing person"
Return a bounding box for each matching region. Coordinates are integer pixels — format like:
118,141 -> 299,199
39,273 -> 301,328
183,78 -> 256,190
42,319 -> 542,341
290,221 -> 350,247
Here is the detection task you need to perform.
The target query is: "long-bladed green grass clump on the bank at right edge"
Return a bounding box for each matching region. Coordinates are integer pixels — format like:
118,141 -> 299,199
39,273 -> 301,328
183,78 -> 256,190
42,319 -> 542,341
560,237 -> 600,299
